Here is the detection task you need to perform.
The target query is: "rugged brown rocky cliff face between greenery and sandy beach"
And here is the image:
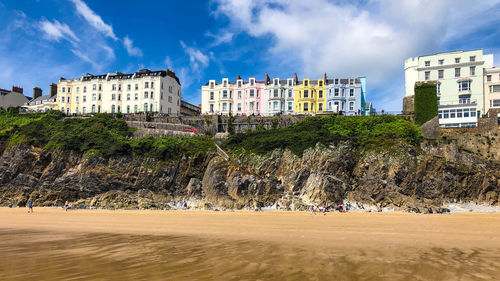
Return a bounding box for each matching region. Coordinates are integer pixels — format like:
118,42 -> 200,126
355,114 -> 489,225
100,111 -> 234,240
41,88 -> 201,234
0,139 -> 500,211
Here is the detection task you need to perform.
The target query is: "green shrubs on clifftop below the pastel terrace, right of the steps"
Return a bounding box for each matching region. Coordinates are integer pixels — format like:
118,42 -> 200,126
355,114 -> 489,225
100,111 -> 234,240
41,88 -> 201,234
223,115 -> 423,156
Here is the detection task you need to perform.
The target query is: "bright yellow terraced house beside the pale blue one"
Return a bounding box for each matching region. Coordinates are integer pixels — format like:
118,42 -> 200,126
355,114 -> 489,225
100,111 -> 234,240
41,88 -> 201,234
295,76 -> 326,114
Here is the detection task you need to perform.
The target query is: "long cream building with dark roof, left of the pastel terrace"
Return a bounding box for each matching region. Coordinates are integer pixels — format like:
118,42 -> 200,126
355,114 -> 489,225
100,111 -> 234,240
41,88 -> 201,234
57,69 -> 181,116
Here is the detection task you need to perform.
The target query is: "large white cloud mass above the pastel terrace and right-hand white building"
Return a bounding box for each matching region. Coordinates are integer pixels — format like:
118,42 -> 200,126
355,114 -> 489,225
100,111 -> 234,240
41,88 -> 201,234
210,0 -> 500,108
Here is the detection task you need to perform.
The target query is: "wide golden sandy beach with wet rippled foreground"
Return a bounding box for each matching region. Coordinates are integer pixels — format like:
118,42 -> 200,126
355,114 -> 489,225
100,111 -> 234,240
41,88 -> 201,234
0,208 -> 500,280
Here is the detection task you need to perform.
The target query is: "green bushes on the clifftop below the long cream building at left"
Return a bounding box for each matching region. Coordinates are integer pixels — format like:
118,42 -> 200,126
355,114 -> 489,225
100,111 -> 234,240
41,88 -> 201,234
0,111 -> 215,160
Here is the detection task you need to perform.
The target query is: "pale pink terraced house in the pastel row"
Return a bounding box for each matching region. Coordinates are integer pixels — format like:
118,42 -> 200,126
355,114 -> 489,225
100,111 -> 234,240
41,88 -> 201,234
233,75 -> 265,116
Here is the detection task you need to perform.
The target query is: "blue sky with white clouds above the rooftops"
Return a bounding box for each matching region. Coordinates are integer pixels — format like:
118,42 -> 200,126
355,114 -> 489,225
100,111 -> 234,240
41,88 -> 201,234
0,0 -> 500,112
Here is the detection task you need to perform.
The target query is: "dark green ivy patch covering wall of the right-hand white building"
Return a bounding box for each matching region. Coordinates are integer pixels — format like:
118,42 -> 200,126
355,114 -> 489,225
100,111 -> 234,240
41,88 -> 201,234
415,83 -> 438,125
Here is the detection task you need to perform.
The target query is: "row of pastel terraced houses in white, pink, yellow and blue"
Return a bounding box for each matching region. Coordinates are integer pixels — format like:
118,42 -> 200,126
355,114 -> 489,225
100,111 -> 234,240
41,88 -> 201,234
201,73 -> 372,116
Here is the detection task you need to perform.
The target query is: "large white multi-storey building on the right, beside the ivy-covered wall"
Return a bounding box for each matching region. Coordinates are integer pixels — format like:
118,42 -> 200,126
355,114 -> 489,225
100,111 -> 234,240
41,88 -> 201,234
405,50 -> 493,127
